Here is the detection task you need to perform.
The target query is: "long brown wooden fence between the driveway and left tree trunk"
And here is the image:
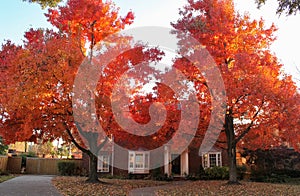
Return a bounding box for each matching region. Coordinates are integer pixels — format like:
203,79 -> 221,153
26,158 -> 82,175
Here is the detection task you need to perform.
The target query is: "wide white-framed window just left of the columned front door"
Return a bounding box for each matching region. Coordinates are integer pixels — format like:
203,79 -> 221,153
128,151 -> 149,174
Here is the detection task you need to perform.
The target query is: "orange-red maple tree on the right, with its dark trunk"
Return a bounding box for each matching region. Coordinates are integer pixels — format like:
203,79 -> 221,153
173,0 -> 299,183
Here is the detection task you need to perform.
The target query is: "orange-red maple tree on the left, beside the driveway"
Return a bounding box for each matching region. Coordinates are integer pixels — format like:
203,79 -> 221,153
1,0 -> 134,182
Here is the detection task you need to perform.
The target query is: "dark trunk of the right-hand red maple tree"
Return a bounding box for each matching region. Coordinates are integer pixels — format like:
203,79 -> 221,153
225,110 -> 239,184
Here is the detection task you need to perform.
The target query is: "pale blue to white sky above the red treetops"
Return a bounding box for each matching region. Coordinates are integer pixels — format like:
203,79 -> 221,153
0,0 -> 300,86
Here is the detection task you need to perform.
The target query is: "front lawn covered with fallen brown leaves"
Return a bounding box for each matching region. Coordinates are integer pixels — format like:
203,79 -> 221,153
53,177 -> 300,196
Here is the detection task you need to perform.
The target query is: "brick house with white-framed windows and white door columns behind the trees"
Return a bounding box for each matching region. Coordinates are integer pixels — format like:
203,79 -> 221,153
83,137 -> 227,176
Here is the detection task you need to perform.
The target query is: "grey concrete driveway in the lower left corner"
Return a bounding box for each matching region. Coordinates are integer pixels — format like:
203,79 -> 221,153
0,175 -> 61,196
